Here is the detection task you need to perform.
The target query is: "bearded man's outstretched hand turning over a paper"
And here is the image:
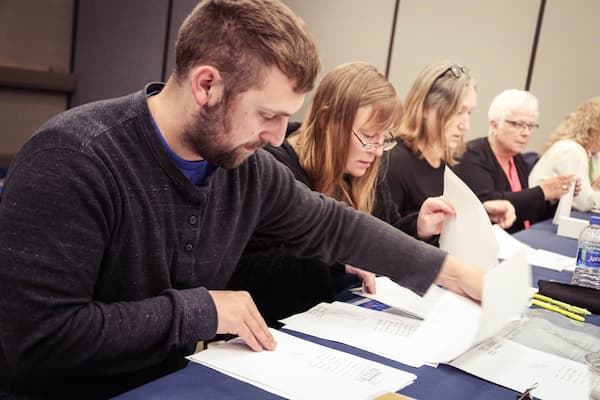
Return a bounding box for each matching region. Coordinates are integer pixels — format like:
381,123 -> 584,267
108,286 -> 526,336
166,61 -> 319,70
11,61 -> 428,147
435,254 -> 483,302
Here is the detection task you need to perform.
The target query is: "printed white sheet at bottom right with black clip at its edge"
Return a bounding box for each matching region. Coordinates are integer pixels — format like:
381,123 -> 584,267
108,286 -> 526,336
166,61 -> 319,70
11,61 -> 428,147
451,337 -> 588,400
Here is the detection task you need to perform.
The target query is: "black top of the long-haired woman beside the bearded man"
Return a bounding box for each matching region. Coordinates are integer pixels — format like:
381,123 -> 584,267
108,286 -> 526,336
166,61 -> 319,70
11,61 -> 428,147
229,141 -> 417,326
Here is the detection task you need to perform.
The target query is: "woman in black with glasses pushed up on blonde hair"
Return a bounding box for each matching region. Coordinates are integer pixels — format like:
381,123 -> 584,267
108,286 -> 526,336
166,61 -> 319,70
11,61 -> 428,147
386,61 -> 477,214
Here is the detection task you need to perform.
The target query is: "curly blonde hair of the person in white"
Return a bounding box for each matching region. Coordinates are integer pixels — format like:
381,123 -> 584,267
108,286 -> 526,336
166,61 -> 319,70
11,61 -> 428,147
542,96 -> 600,154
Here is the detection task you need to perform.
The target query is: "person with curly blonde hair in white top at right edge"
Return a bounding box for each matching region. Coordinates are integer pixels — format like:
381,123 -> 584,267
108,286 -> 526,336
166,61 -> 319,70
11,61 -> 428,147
529,97 -> 600,211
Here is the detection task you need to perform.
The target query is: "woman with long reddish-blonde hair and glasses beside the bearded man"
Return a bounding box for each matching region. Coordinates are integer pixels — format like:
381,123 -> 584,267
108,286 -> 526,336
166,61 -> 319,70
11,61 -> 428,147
229,62 -> 462,325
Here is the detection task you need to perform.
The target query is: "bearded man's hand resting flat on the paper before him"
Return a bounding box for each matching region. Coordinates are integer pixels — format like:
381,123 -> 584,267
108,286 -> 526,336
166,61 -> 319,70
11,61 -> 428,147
208,290 -> 277,351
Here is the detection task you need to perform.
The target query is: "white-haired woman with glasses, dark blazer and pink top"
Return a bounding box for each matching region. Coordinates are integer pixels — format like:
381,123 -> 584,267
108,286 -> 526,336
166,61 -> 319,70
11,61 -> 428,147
454,89 -> 574,232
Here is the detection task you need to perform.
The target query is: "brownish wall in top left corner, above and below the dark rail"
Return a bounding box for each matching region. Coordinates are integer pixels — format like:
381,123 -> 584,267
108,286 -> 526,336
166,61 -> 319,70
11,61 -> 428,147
0,0 -> 73,159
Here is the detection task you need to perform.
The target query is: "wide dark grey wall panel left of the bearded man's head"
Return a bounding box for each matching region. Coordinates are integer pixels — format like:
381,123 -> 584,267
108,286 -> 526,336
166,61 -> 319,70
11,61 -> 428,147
71,0 -> 170,106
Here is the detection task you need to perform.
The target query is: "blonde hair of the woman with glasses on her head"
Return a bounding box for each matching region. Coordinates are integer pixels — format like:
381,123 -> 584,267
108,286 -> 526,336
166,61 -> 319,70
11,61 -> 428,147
397,60 -> 475,165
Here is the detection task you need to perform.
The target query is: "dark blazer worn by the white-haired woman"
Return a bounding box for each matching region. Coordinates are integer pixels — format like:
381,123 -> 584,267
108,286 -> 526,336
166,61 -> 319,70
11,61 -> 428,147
453,137 -> 556,233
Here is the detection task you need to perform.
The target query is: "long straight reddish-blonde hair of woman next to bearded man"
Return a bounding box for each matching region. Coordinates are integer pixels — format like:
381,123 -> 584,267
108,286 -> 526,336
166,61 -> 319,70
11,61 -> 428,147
290,62 -> 402,213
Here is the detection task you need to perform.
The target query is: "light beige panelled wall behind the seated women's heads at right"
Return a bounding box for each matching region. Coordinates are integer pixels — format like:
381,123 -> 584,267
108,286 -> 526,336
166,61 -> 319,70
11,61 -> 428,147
286,0 -> 600,151
